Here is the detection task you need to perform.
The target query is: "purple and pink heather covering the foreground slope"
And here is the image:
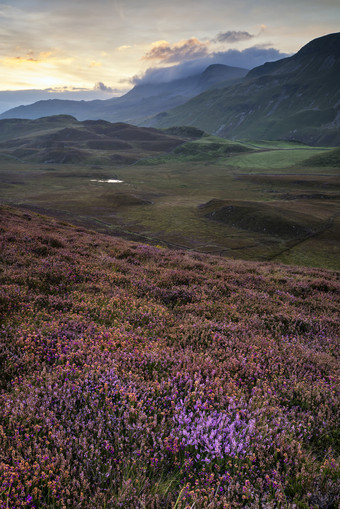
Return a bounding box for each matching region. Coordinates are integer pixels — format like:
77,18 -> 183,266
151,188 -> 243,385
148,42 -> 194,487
0,207 -> 340,509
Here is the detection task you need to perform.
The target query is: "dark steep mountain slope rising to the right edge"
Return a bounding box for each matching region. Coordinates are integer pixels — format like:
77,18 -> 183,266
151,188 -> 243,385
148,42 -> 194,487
149,33 -> 340,146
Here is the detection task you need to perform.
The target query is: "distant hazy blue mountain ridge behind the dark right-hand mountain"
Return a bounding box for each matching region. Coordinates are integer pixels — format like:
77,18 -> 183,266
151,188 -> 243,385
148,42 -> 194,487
0,65 -> 247,124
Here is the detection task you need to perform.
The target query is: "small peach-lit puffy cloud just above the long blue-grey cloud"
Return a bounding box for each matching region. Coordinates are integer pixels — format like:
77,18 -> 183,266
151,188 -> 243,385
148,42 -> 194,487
143,37 -> 209,63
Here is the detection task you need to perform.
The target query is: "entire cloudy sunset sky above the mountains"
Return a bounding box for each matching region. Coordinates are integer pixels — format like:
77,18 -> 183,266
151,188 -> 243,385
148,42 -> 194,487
0,0 -> 340,109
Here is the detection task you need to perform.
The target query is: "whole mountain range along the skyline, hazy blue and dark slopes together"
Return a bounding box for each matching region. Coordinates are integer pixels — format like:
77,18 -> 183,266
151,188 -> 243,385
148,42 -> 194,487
0,33 -> 340,146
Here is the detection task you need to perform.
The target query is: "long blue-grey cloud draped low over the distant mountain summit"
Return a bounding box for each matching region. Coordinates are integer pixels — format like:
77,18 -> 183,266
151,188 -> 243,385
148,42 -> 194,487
132,46 -> 289,85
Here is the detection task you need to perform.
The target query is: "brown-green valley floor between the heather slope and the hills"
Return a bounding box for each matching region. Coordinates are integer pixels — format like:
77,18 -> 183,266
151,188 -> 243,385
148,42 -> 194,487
0,136 -> 340,269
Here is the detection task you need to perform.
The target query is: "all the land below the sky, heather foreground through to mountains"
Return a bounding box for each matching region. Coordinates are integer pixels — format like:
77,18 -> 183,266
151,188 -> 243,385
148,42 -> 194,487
0,29 -> 340,509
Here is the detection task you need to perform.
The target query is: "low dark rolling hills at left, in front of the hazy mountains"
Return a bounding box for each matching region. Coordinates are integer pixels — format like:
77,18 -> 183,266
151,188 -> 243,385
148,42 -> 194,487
0,115 -> 203,164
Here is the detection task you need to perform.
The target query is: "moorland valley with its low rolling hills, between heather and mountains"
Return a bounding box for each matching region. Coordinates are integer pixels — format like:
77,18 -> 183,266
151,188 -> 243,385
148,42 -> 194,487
0,116 -> 340,269
